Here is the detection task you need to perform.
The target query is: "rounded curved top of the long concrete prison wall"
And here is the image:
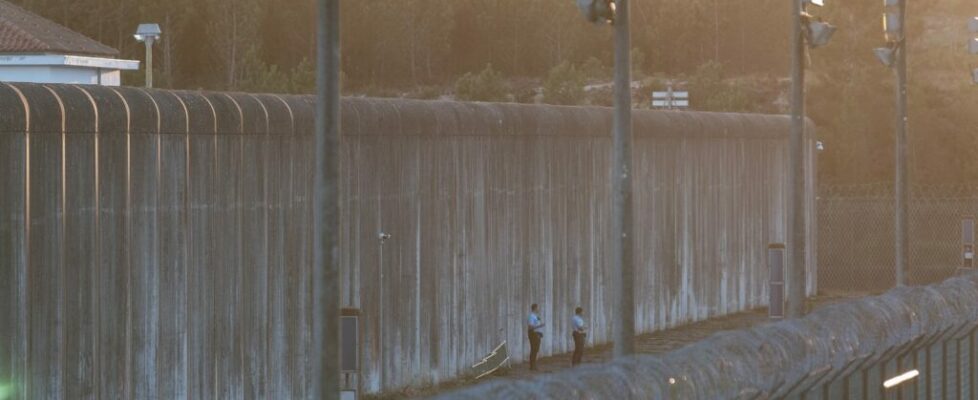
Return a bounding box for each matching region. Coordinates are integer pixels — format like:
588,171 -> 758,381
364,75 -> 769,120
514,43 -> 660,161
0,83 -> 814,139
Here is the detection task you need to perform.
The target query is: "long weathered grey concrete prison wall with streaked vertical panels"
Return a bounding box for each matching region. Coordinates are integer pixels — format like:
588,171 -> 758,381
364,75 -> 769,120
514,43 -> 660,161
0,84 -> 815,399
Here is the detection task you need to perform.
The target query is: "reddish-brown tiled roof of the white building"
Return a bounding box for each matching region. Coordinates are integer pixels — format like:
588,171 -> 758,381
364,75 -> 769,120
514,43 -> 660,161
0,0 -> 119,57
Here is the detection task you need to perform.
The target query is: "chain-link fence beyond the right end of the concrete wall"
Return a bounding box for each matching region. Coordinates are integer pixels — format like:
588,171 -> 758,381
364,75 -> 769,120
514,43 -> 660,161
817,184 -> 978,293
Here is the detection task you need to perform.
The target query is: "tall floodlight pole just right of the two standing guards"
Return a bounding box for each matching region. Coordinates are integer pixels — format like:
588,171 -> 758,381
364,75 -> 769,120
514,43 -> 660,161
577,0 -> 635,358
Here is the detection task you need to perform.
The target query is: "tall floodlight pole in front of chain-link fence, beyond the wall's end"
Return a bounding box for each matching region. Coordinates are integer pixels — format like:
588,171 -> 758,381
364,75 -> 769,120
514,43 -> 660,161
875,0 -> 910,286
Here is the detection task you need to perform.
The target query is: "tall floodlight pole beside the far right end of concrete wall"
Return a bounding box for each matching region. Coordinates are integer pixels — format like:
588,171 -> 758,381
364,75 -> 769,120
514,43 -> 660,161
785,0 -> 835,318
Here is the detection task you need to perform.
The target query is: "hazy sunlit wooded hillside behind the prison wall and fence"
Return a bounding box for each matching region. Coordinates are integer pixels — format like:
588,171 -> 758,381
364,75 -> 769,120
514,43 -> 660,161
13,0 -> 978,183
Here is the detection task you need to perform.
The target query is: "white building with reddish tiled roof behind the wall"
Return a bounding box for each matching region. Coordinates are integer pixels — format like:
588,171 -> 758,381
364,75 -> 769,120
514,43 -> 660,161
0,0 -> 139,86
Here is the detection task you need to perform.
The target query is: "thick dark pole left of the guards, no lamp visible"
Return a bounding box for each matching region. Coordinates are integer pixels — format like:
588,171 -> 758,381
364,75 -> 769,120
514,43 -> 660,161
309,0 -> 340,400
